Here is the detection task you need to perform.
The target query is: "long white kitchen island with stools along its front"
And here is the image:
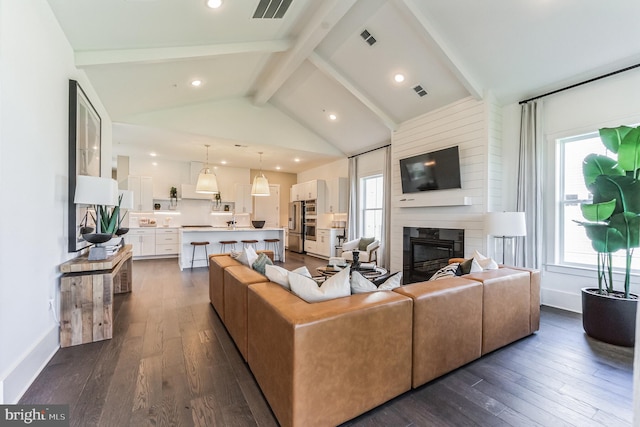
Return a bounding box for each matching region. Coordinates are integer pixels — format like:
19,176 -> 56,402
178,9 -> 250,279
178,227 -> 285,270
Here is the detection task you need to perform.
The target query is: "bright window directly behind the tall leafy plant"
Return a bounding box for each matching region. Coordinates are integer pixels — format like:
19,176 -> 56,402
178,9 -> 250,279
558,132 -> 640,269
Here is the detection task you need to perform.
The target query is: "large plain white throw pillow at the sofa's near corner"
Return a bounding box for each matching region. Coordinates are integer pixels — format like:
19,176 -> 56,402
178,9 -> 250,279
289,267 -> 351,302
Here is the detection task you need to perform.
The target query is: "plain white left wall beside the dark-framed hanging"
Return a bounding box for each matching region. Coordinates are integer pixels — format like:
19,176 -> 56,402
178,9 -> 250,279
0,0 -> 111,403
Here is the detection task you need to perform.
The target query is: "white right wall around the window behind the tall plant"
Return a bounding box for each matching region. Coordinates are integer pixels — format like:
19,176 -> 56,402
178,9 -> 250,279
503,70 -> 640,312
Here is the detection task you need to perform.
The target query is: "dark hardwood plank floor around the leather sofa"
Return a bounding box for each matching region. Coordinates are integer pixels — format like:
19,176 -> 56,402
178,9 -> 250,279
20,253 -> 633,427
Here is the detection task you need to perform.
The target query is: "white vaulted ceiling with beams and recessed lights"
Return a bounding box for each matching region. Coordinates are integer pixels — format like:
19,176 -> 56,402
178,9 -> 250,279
49,0 -> 640,173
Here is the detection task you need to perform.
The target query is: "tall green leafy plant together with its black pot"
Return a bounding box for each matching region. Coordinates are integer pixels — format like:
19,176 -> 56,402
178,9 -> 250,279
578,126 -> 640,347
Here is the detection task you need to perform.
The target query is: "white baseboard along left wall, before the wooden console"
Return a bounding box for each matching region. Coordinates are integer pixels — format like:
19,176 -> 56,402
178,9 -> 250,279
0,325 -> 60,405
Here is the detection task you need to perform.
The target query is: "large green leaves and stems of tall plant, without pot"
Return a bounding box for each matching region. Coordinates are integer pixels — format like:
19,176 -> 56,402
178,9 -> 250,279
579,126 -> 640,298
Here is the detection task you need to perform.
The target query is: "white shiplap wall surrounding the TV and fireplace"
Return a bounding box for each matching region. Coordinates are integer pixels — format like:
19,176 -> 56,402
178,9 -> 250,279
391,96 -> 502,271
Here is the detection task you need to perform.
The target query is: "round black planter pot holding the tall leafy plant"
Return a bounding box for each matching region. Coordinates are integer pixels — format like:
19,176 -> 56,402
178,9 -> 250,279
582,288 -> 638,347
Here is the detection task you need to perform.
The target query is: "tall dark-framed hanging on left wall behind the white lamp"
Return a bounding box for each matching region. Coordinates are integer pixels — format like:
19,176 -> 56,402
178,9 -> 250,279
68,80 -> 102,252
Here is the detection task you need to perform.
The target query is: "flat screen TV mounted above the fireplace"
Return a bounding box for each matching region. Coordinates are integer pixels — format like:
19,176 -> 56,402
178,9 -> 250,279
400,146 -> 462,193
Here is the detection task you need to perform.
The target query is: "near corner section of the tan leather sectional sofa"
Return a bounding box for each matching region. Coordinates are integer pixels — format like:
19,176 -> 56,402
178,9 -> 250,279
248,283 -> 412,427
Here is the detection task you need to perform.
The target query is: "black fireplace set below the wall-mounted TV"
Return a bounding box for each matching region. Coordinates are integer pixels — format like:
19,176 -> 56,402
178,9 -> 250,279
402,227 -> 464,285
